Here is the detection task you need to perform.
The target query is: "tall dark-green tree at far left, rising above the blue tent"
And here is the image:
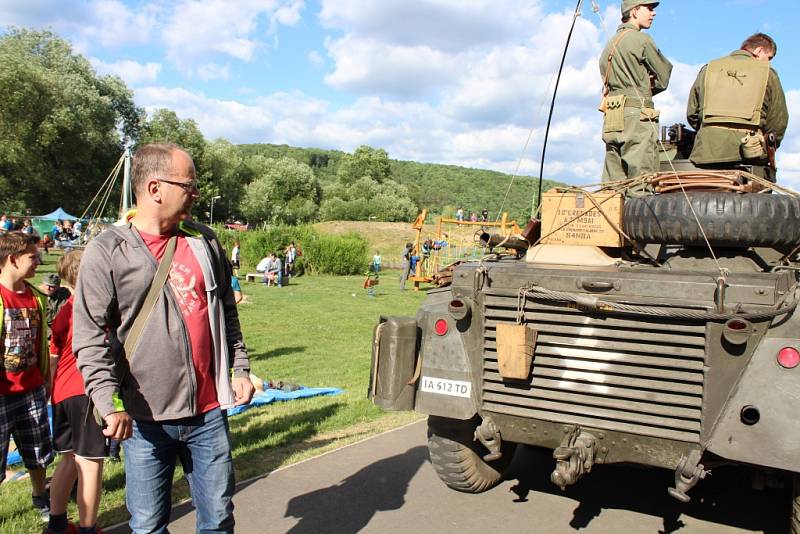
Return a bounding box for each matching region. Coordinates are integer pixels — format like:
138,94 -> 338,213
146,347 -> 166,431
0,29 -> 143,214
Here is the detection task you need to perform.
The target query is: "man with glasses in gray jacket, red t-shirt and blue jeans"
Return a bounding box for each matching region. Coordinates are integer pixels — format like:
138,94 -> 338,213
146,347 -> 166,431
73,143 -> 254,533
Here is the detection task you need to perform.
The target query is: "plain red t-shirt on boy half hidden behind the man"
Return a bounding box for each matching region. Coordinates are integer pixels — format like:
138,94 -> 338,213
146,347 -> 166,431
50,297 -> 86,404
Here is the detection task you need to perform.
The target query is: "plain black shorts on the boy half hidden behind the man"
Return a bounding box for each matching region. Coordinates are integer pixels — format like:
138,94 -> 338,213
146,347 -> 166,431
53,395 -> 108,459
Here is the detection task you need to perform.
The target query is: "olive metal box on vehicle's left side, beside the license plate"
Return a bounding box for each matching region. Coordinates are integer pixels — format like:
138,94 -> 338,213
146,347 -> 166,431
369,317 -> 417,410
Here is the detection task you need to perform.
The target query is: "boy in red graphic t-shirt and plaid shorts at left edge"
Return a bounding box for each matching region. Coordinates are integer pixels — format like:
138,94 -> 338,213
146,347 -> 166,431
0,232 -> 53,520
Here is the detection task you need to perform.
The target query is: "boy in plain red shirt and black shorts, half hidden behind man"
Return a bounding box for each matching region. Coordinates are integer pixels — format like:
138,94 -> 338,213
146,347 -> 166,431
45,251 -> 107,534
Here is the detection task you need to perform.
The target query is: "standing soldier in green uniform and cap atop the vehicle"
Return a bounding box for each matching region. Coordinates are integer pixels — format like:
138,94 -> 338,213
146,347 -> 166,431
600,0 -> 672,182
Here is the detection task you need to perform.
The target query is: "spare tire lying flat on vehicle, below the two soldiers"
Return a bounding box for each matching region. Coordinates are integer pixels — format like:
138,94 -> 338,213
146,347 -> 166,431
624,191 -> 800,248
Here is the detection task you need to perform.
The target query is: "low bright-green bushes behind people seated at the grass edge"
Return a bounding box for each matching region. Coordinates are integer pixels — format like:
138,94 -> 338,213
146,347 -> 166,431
209,225 -> 369,276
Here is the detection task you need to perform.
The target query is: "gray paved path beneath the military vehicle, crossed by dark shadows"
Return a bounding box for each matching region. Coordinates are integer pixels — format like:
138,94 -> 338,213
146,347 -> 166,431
107,422 -> 789,534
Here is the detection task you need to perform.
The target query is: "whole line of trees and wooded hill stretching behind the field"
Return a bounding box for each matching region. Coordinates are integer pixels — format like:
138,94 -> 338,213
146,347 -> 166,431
0,29 -> 559,225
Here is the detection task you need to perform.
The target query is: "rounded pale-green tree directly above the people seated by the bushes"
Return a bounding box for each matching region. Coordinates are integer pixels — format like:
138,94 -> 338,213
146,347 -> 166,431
242,156 -> 321,224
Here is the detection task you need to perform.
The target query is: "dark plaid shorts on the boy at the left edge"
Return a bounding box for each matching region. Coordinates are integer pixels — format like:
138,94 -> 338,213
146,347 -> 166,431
0,386 -> 53,482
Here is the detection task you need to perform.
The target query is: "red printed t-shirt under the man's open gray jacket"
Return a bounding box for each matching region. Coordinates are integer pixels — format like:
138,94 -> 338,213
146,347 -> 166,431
139,231 -> 219,413
